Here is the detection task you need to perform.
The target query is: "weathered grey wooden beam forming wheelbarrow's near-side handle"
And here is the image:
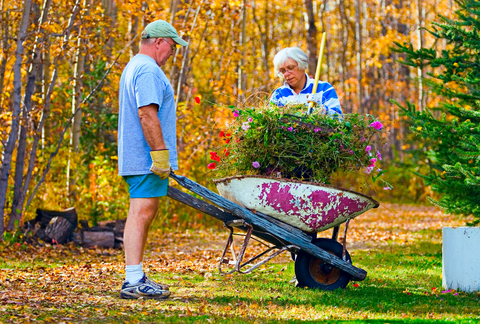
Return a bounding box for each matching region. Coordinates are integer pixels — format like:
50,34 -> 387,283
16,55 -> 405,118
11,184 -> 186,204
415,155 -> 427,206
170,173 -> 367,280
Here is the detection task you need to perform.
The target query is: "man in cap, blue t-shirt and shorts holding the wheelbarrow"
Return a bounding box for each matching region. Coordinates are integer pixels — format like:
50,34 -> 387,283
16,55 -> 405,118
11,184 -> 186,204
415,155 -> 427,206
118,20 -> 188,299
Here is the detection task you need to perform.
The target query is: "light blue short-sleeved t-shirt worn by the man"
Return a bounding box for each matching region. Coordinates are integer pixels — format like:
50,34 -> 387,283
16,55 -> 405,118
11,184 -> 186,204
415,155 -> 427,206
118,54 -> 178,176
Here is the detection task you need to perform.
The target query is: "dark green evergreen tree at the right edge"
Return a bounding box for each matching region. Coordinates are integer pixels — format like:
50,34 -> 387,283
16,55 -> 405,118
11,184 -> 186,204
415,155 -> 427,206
392,0 -> 480,225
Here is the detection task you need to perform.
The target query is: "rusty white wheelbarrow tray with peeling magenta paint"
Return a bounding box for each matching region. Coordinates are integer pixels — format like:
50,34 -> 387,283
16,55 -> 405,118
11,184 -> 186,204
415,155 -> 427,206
214,176 -> 379,232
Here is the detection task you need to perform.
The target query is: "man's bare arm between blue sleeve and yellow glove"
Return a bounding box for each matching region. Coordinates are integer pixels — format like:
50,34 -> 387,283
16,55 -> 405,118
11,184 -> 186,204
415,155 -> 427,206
138,104 -> 167,151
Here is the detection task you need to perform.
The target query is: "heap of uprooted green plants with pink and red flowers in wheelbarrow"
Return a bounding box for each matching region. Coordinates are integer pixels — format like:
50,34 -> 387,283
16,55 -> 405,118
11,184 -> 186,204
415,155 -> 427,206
209,105 -> 383,183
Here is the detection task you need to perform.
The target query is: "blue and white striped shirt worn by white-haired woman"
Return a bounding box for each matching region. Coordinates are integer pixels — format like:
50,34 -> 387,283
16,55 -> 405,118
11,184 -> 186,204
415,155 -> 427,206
270,74 -> 343,116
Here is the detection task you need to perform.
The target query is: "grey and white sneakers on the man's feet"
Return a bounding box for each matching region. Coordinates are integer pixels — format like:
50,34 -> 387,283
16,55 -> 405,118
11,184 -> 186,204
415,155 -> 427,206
120,275 -> 170,299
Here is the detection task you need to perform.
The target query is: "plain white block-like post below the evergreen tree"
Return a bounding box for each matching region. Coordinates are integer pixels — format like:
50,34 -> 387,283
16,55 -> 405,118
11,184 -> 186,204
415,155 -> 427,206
442,227 -> 480,292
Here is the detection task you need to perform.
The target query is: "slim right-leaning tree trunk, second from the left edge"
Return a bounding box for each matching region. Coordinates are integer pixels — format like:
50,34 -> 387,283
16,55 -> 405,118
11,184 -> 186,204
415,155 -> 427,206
7,0 -> 52,230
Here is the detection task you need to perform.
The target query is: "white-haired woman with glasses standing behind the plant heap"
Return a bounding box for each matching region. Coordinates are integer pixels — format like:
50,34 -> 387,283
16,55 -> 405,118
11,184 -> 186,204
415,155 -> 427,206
270,47 -> 342,116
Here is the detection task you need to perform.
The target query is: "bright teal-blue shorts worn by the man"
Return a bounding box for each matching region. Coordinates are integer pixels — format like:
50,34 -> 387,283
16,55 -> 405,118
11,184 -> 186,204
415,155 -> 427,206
123,173 -> 168,198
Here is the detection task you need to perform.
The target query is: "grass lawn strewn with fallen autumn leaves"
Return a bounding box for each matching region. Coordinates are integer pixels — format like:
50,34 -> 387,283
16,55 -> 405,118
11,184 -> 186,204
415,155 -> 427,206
0,205 -> 480,323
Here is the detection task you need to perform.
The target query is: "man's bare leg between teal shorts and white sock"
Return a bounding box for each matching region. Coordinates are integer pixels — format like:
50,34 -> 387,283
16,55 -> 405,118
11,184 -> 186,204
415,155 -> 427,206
123,197 -> 159,266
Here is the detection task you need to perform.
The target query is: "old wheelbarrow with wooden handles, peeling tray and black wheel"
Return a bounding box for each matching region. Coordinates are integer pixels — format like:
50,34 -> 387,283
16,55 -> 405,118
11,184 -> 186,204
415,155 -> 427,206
168,173 -> 379,290
